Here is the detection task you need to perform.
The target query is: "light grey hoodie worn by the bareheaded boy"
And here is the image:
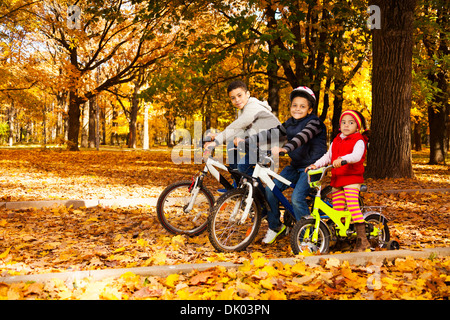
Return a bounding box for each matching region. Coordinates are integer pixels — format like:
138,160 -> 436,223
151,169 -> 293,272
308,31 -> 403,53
215,97 -> 281,145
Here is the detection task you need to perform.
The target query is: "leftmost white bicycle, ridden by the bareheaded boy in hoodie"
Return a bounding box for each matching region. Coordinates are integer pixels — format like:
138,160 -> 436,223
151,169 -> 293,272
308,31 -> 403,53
156,139 -> 244,236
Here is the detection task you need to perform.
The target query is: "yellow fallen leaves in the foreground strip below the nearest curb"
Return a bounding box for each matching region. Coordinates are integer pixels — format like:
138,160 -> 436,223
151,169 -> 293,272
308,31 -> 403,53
0,252 -> 450,300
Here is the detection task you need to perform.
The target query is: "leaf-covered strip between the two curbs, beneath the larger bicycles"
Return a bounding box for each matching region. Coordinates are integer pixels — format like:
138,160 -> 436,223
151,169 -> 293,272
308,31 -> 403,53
0,190 -> 450,276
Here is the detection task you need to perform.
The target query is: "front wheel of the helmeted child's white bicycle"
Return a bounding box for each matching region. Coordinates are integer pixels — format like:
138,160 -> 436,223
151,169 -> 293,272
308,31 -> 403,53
208,189 -> 261,252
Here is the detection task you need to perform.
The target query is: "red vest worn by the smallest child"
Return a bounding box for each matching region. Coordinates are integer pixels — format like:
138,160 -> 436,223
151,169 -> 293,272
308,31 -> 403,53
330,132 -> 366,188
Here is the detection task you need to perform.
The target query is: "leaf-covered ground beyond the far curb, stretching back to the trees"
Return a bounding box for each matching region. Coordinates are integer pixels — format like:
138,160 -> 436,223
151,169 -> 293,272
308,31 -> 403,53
0,149 -> 450,201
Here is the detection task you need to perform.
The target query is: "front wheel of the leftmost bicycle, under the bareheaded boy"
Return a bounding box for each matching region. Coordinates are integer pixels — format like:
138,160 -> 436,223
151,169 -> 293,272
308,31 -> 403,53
156,180 -> 215,236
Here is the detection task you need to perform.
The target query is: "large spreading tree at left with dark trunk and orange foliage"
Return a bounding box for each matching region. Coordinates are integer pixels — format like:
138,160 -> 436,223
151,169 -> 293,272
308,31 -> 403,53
36,0 -> 187,150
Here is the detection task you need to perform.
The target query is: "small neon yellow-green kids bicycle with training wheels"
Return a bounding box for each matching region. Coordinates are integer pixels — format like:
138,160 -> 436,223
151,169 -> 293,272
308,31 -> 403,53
290,162 -> 398,254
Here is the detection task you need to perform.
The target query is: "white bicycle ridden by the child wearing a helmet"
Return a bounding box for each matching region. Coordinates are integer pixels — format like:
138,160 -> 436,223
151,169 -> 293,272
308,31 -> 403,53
208,153 -> 342,252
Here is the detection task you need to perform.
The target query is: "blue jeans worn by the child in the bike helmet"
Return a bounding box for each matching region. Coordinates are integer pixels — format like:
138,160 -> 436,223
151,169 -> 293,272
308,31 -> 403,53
265,166 -> 311,231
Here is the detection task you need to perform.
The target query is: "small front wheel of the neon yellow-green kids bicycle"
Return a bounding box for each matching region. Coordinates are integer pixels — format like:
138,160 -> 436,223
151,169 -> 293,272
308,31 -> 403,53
290,219 -> 330,255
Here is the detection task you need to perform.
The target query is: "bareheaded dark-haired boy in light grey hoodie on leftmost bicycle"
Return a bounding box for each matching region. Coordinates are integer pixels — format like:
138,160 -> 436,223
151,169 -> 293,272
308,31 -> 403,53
205,80 -> 281,174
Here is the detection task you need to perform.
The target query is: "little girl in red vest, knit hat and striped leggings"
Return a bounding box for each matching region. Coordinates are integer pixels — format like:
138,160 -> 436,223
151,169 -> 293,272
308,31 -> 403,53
307,110 -> 370,251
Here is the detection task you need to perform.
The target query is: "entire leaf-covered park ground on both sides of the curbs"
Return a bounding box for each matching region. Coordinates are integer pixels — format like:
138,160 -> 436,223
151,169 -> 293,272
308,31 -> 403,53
0,150 -> 450,299
